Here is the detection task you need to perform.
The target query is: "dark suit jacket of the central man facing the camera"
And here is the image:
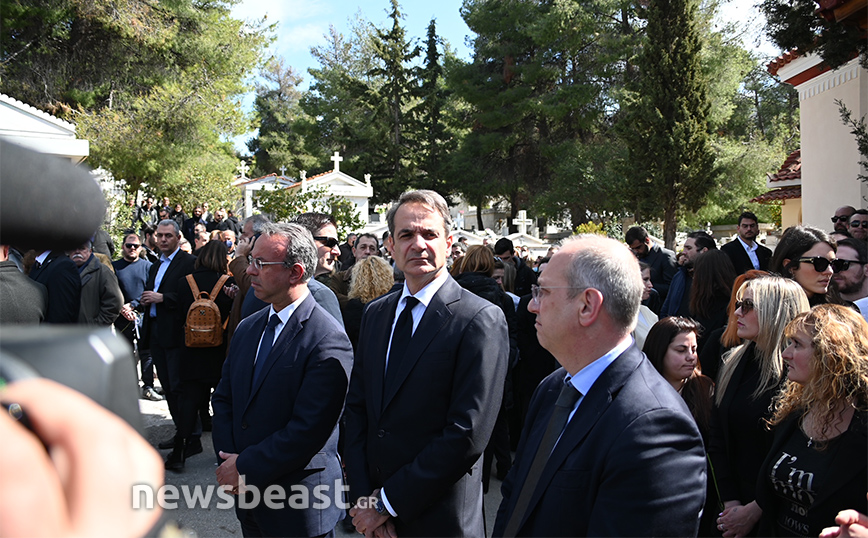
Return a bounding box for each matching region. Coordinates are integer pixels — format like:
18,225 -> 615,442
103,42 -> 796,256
344,277 -> 509,536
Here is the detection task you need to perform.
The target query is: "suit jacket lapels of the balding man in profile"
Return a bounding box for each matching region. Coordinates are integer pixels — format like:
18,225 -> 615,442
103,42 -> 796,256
519,346 -> 643,528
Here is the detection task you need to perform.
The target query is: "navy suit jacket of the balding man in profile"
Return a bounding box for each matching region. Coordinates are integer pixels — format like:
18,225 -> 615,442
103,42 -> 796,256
493,346 -> 706,536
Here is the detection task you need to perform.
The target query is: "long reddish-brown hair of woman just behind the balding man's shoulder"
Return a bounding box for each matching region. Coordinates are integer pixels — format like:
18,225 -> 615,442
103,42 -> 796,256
642,316 -> 712,433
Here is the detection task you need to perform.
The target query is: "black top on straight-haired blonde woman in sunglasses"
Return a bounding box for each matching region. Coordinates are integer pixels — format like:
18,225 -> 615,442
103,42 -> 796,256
708,342 -> 779,536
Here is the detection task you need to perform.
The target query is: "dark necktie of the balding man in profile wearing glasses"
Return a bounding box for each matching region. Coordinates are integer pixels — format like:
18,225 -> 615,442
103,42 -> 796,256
503,382 -> 582,536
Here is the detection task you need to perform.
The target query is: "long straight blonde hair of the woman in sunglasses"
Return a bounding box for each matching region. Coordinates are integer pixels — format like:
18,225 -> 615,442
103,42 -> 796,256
715,276 -> 811,405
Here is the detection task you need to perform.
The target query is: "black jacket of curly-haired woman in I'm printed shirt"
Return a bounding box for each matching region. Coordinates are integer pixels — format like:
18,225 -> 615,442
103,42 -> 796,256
756,412 -> 868,536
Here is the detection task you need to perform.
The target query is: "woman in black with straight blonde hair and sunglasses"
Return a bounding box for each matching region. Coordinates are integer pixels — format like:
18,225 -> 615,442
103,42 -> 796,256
708,277 -> 810,538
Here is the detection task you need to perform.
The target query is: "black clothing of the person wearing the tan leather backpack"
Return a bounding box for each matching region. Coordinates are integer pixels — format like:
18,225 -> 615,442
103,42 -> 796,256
178,267 -> 235,438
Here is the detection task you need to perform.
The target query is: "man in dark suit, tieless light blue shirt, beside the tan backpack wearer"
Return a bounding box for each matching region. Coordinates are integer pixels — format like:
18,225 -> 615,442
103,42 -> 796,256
139,219 -> 196,436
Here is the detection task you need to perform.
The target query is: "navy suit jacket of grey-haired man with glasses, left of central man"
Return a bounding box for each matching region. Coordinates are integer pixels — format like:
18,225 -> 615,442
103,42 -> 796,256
212,295 -> 353,536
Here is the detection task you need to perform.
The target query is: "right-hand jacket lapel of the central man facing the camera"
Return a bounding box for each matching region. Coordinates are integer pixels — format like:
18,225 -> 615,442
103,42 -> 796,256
382,278 -> 461,409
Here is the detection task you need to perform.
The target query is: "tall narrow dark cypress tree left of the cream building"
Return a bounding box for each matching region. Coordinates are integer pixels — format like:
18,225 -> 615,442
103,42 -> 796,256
622,0 -> 719,248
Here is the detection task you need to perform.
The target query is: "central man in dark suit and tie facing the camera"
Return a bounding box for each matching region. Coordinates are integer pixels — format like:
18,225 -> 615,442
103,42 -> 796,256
344,191 -> 509,536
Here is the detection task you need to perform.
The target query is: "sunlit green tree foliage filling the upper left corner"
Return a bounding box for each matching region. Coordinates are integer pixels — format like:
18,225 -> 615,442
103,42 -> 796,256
0,0 -> 270,192
